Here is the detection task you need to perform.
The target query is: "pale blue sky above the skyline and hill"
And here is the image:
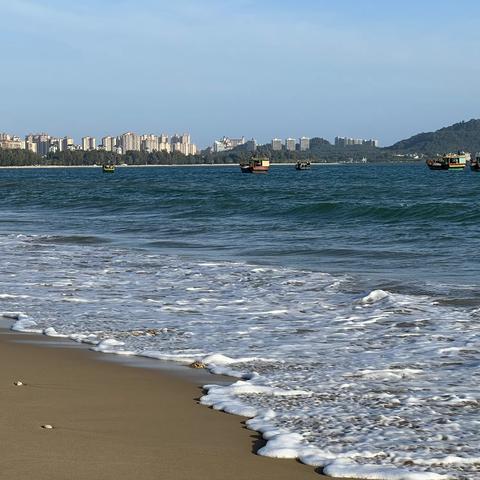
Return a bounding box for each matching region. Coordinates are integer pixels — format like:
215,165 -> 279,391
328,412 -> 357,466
0,0 -> 480,147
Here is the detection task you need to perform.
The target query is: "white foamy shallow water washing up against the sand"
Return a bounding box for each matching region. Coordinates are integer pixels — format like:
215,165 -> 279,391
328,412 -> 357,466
0,232 -> 480,480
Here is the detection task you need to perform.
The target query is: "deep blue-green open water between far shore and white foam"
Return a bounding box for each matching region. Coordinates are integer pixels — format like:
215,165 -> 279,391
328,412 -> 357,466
0,165 -> 480,302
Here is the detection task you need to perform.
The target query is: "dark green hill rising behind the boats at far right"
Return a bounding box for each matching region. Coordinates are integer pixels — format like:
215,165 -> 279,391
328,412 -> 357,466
386,120 -> 480,155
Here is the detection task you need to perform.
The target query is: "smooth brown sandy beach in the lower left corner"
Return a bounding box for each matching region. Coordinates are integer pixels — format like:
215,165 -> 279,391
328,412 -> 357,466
0,329 -> 344,480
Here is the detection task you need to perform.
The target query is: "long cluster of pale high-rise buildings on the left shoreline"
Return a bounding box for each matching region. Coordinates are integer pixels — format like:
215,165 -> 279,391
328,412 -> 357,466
0,132 -> 198,156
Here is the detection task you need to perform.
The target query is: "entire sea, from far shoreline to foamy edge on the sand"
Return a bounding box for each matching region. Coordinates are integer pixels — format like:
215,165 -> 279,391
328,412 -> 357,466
0,165 -> 480,480
